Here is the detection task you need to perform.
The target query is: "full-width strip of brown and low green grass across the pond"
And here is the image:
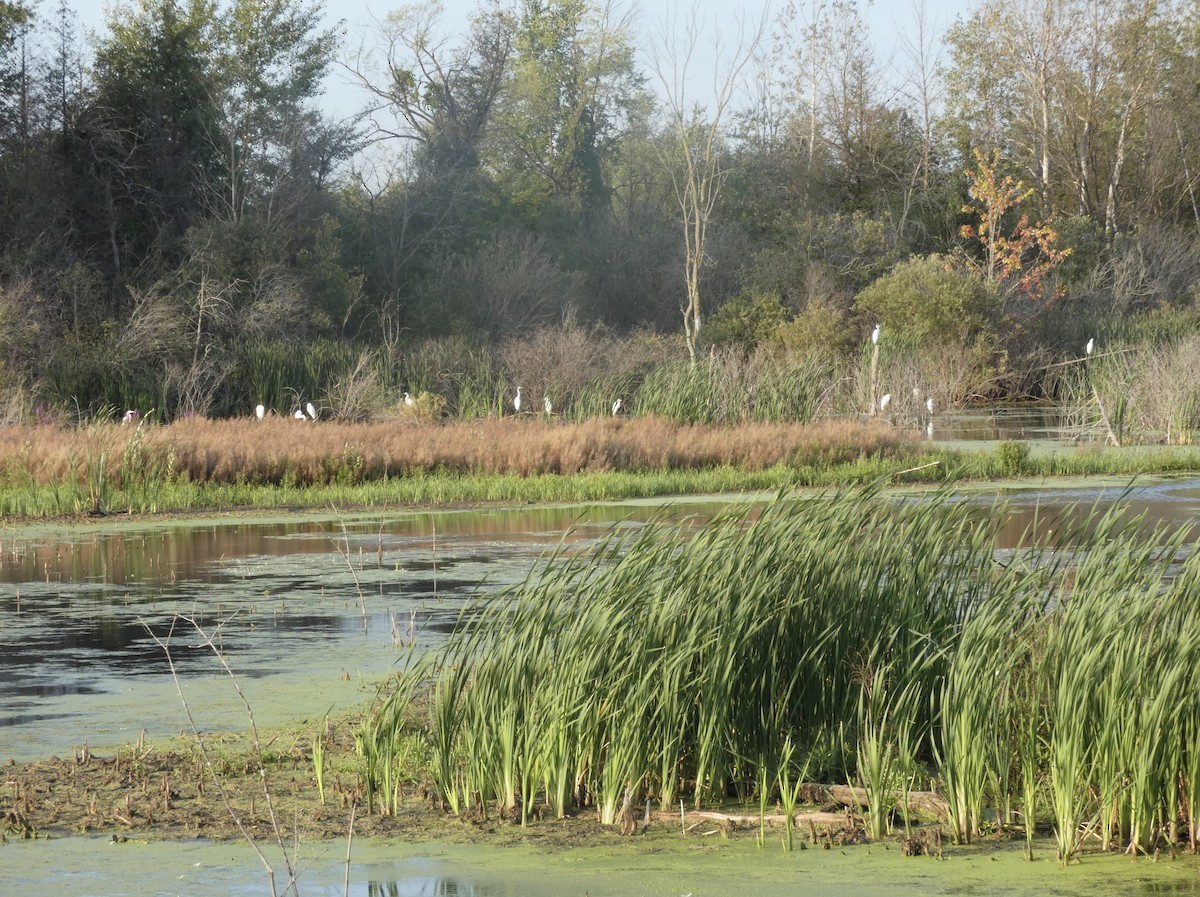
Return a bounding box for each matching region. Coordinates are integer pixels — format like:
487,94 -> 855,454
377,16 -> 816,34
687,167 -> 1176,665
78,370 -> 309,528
0,413 -> 1200,517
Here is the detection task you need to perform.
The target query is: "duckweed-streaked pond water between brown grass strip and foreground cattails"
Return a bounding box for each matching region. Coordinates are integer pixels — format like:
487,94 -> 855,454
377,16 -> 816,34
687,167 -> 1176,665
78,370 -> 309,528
0,480 -> 1200,760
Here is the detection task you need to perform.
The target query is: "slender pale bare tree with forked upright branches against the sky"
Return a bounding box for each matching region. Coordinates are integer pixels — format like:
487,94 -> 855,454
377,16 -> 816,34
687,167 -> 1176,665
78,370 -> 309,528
649,6 -> 767,361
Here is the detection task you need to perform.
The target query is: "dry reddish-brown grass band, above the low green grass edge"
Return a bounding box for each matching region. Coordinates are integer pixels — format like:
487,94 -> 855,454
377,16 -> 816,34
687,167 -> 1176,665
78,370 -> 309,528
0,417 -> 910,484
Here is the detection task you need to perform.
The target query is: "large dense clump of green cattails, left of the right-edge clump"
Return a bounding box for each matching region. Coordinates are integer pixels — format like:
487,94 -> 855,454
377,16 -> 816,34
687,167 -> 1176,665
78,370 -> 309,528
360,493 -> 991,824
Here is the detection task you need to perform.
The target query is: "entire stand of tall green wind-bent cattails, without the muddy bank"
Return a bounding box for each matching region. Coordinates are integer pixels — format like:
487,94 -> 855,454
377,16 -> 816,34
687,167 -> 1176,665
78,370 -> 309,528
357,490 -> 1200,862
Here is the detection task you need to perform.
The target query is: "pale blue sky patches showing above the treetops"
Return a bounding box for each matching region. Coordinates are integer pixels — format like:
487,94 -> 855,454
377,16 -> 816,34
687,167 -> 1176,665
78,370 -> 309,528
58,0 -> 974,125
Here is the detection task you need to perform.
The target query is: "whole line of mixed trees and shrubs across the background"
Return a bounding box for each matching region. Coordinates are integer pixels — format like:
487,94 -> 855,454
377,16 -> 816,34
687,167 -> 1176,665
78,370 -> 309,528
0,0 -> 1200,421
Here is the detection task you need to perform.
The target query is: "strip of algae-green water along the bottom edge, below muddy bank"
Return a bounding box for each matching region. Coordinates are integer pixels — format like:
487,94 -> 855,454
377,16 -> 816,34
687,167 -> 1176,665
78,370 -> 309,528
7,832 -> 1200,897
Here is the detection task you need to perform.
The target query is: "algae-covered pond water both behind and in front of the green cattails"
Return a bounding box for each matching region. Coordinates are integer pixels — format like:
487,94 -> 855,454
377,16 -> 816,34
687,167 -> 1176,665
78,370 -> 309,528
0,480 -> 1200,897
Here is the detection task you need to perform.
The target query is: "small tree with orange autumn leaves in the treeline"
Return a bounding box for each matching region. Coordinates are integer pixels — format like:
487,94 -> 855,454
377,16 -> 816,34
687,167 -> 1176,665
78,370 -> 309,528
960,150 -> 1070,300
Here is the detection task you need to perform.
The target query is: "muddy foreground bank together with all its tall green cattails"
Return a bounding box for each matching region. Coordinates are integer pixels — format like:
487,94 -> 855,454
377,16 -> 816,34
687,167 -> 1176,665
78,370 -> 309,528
14,489 -> 1200,877
